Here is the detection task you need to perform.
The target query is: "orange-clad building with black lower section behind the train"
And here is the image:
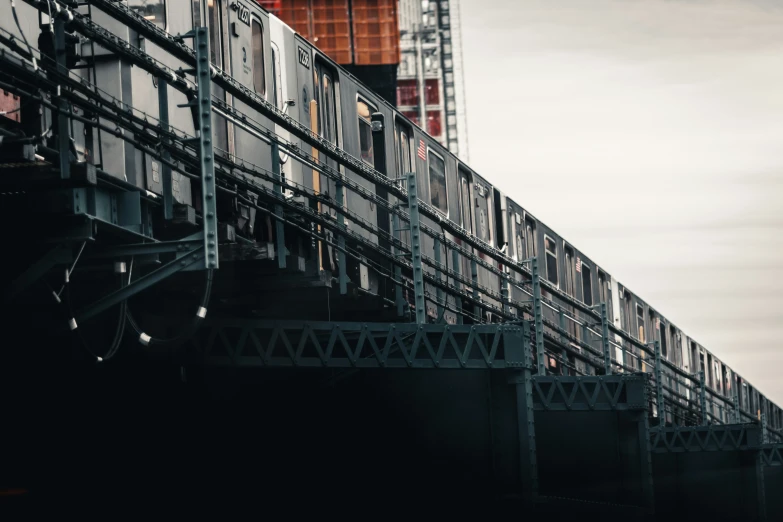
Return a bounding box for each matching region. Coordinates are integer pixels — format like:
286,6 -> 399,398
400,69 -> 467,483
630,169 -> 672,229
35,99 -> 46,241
256,0 -> 400,104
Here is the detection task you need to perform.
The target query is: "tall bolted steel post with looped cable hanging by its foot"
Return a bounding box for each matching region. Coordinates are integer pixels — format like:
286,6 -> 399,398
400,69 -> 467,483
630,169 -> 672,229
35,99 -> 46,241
196,27 -> 218,268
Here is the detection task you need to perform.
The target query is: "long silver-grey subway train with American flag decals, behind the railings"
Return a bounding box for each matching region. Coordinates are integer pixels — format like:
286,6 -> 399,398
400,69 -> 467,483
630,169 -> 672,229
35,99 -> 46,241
0,0 -> 783,429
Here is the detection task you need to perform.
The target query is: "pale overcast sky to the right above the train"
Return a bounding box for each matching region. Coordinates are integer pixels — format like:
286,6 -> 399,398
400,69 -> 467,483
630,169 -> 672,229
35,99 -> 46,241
461,0 -> 783,406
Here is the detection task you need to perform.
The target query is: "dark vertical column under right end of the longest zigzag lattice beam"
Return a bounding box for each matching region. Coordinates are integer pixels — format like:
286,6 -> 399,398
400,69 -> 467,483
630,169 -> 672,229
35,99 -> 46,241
505,321 -> 538,503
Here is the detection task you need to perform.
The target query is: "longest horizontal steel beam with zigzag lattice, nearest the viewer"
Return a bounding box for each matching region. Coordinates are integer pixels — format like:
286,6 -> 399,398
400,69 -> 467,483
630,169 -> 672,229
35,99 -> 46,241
194,319 -> 524,370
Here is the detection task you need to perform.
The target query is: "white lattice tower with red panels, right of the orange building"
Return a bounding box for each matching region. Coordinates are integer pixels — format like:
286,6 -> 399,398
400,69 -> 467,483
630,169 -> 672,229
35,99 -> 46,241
397,0 -> 468,161
